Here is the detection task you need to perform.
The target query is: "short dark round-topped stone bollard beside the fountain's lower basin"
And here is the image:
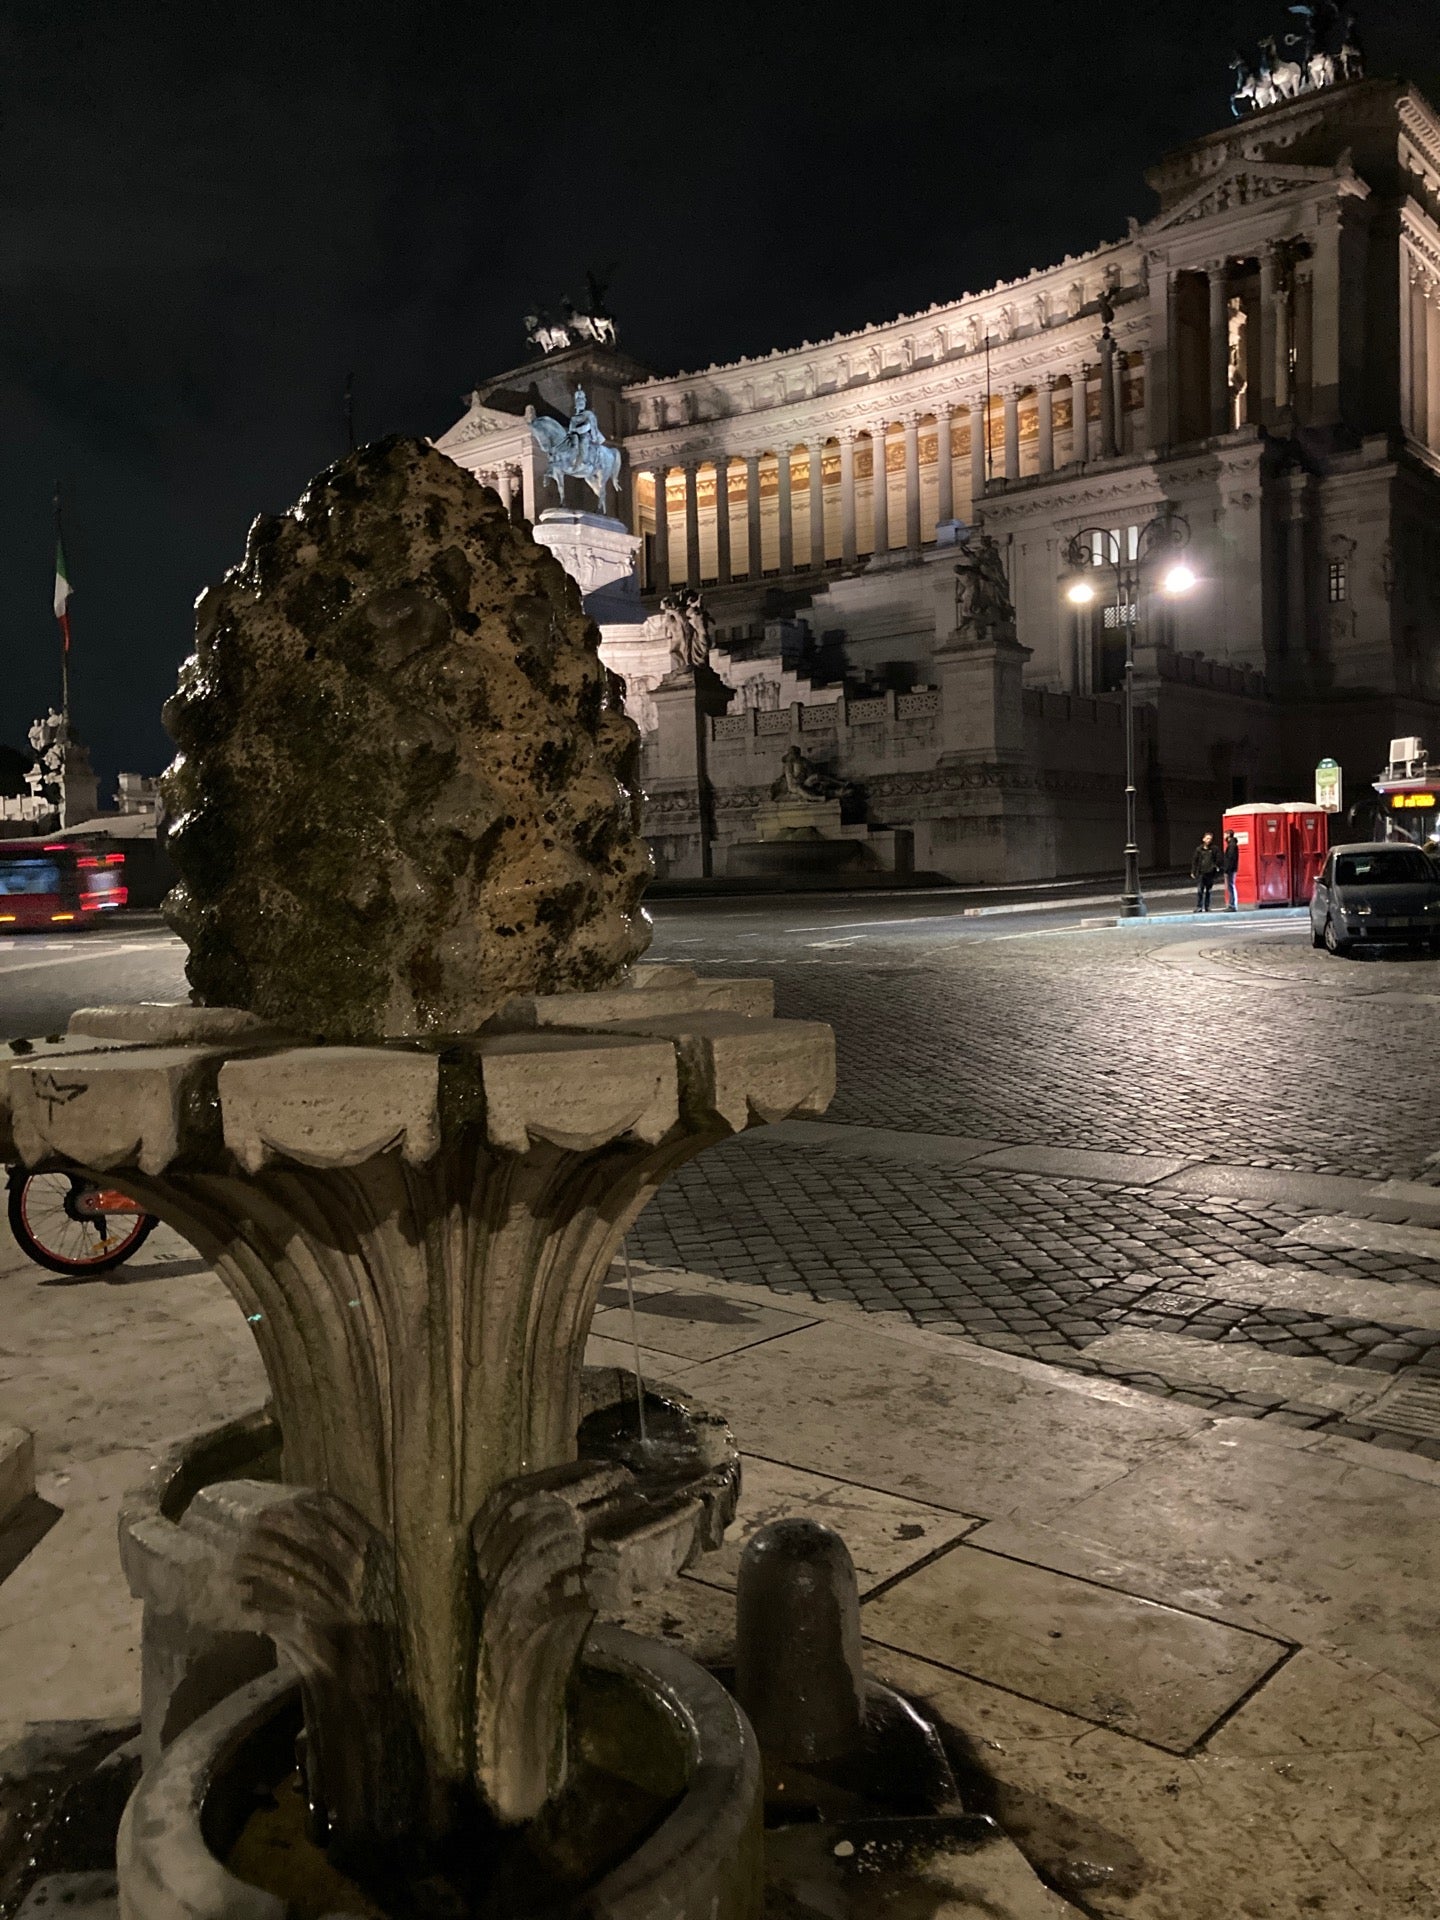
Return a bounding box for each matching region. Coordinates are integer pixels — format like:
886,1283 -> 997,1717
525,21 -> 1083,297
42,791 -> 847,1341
735,1519 -> 866,1763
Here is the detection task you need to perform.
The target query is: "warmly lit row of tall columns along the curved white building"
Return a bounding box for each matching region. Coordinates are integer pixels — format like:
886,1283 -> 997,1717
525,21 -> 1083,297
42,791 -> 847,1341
636,360 -> 1136,593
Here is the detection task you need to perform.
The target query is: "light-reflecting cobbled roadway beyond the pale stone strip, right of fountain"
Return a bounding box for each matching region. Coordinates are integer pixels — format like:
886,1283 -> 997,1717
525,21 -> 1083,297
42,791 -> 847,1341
683,922 -> 1440,1177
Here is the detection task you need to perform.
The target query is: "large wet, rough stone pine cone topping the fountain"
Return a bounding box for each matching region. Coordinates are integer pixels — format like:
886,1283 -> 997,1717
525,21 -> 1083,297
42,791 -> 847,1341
165,438 -> 651,1041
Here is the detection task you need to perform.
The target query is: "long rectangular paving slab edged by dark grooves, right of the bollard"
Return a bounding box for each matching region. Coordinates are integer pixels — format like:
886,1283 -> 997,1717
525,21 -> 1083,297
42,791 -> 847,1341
862,1546 -> 1290,1753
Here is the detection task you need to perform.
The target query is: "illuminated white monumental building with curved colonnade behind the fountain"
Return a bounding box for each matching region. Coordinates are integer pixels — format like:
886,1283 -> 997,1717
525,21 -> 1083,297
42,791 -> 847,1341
438,79 -> 1440,879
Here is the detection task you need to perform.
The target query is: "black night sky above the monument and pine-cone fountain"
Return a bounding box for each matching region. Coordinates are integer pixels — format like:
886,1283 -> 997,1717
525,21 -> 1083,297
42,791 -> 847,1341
0,0 -> 1440,794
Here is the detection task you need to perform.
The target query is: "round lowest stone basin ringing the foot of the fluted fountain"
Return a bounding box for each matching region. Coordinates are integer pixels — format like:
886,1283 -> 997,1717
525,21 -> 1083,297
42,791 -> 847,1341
117,1626 -> 762,1920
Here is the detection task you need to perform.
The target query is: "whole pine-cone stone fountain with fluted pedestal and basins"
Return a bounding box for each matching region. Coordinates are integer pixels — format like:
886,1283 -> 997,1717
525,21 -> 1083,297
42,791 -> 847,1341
0,440 -> 833,1920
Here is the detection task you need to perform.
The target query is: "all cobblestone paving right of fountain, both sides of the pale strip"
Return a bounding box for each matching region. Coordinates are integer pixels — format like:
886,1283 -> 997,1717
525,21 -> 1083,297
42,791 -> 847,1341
632,906 -> 1440,1457
